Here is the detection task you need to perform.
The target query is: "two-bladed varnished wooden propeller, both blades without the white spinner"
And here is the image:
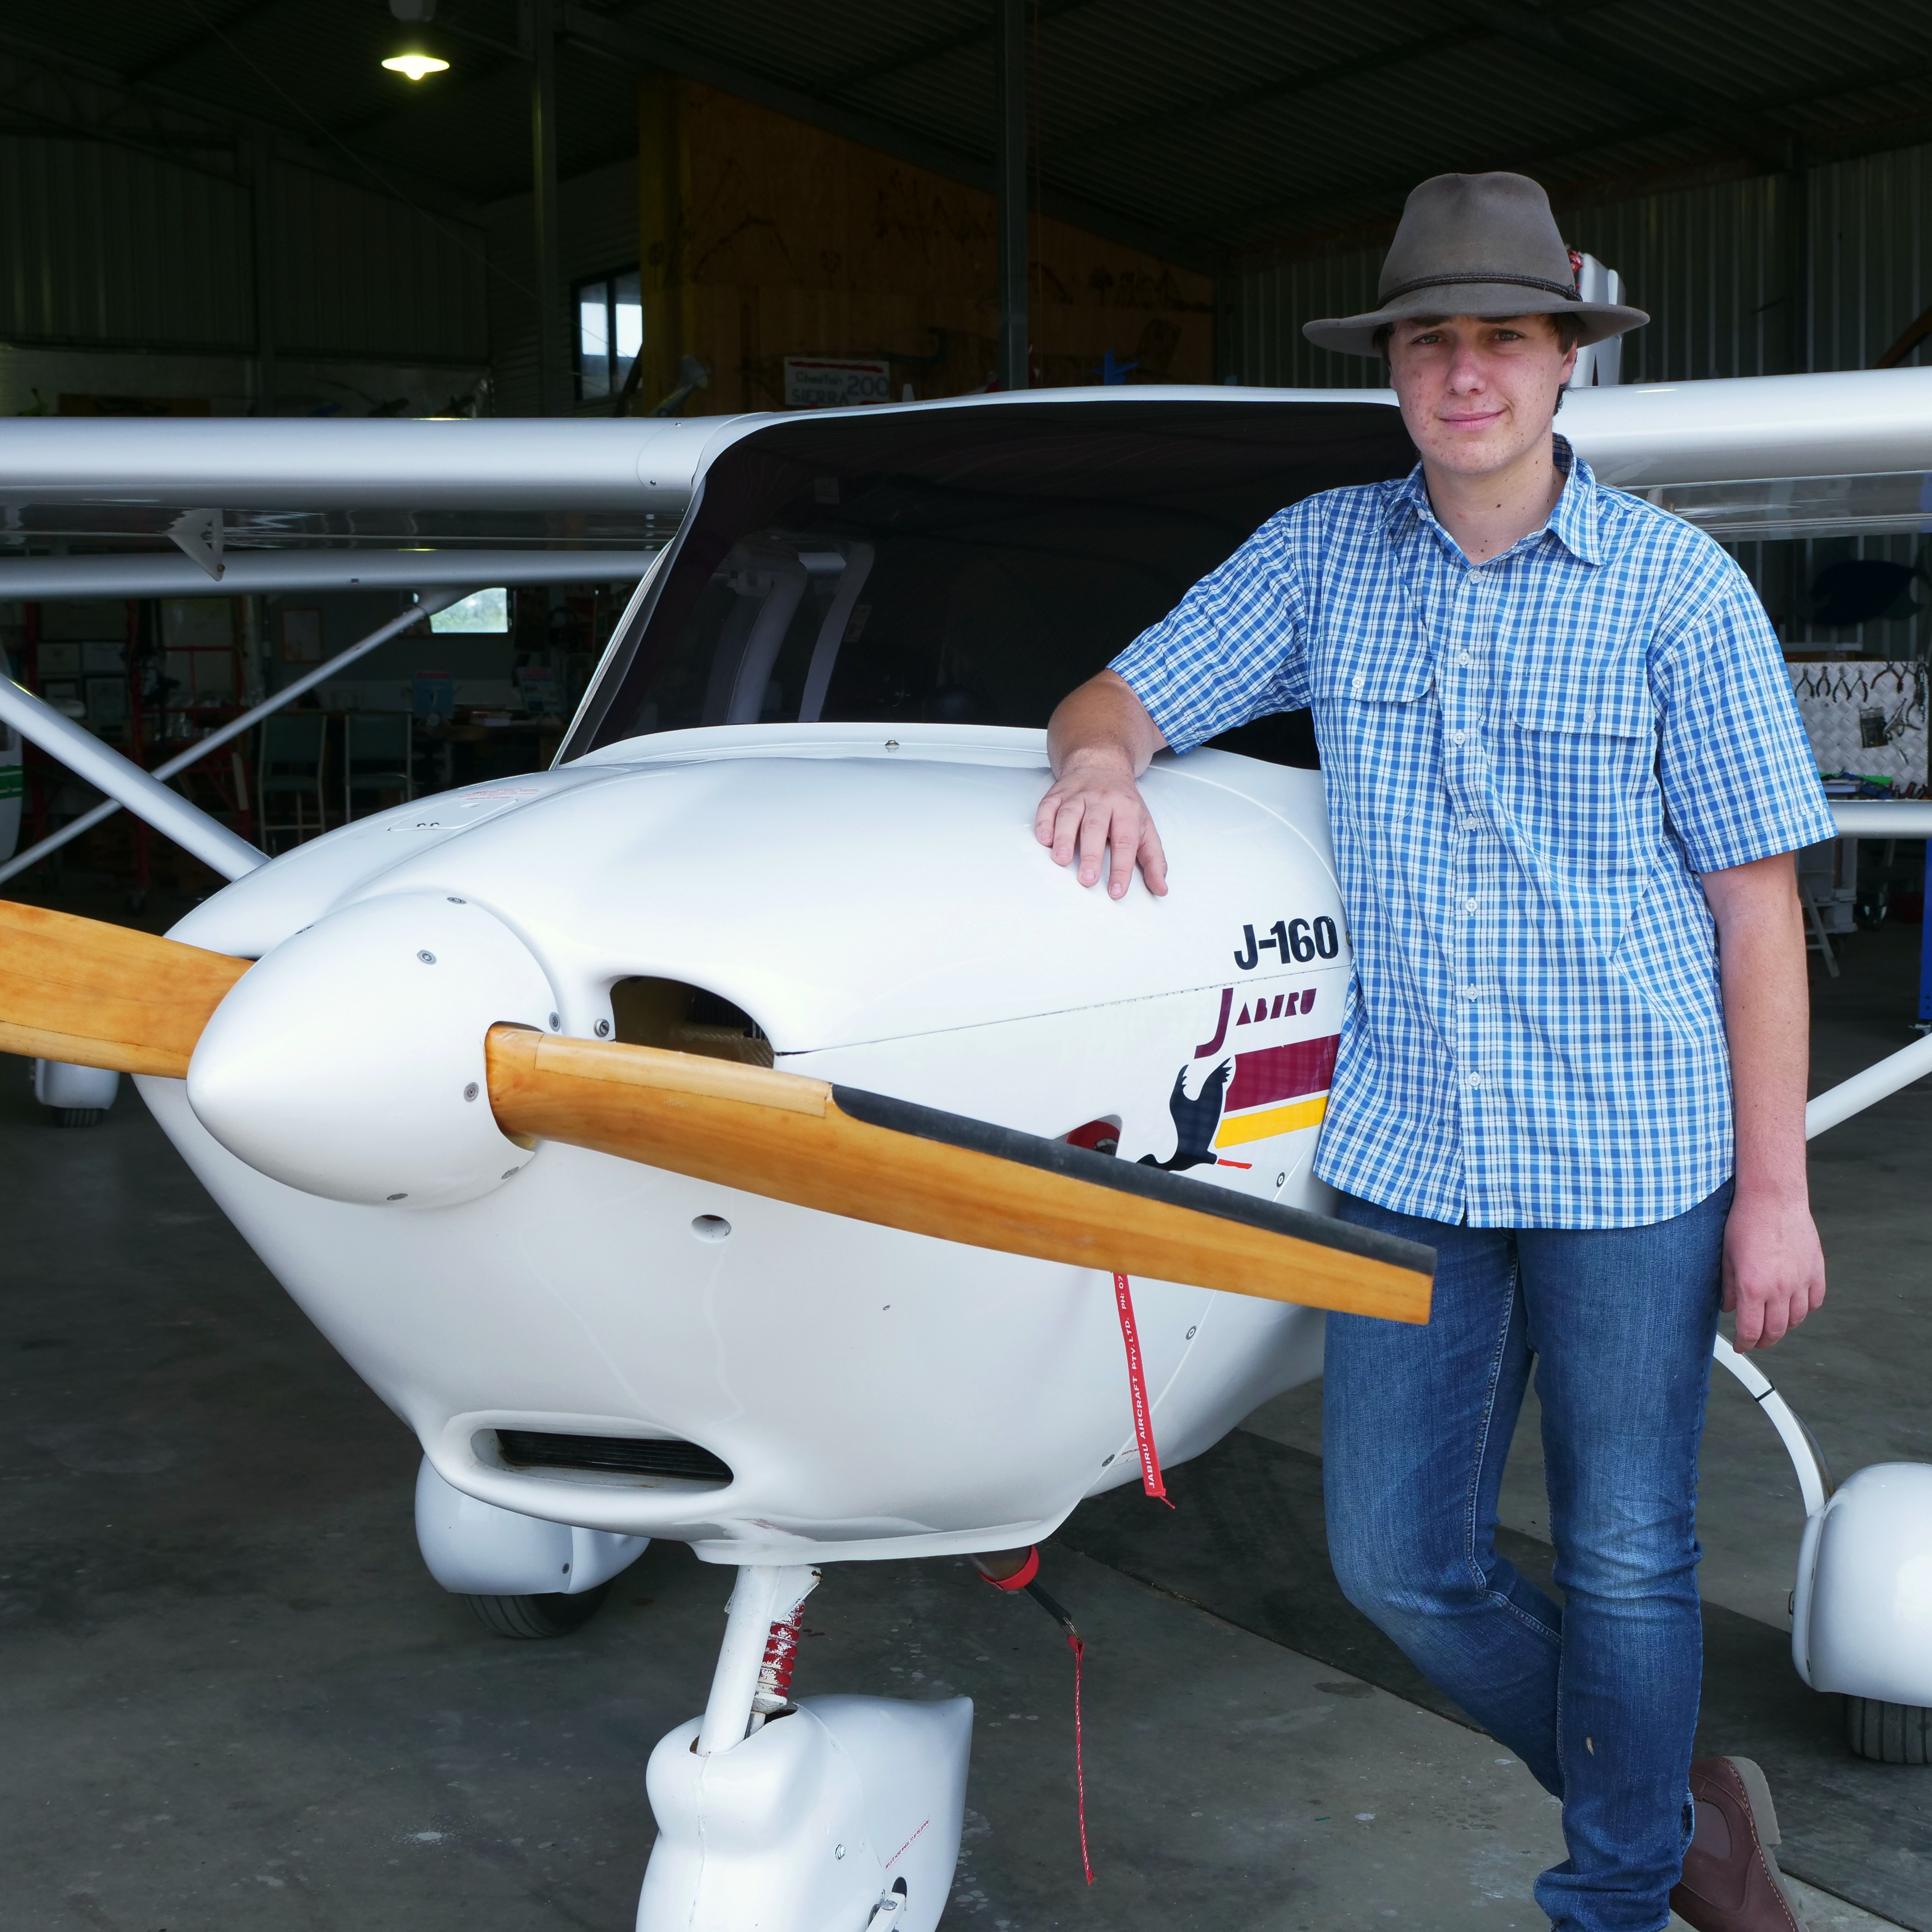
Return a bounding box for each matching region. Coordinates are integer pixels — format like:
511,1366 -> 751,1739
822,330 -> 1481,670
0,902 -> 1436,1321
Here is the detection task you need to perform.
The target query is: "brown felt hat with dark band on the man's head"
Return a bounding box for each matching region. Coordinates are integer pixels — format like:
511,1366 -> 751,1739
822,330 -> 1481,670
1302,174 -> 1650,355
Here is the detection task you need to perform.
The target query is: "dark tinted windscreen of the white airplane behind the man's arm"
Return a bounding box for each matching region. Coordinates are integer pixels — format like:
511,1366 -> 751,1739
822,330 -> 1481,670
566,392 -> 1414,763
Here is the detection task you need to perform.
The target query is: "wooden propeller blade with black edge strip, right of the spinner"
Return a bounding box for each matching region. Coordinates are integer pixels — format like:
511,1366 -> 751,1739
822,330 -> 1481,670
487,1026 -> 1436,1321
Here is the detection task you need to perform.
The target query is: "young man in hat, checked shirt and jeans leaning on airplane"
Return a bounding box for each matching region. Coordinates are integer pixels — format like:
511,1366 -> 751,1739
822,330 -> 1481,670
1038,174 -> 1836,1932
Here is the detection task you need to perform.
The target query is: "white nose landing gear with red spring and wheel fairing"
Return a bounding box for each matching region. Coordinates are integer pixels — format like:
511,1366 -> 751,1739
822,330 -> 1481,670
638,1565 -> 972,1932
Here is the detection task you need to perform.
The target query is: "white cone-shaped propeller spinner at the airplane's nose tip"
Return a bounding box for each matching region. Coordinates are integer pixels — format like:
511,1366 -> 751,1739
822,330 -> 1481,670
187,892 -> 557,1208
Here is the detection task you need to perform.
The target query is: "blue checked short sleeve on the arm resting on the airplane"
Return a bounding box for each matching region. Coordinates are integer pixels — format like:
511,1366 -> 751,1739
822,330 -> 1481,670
1109,504 -> 1308,751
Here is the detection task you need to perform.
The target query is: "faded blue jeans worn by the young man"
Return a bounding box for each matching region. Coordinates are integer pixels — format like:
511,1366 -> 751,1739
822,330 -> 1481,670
1321,1182 -> 1731,1932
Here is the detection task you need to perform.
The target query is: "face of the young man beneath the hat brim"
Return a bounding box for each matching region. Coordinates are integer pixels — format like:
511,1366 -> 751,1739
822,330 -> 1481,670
1389,315 -> 1577,477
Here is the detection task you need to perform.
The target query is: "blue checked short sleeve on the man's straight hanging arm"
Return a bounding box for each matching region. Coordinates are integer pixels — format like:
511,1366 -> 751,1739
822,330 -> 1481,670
1652,553 -> 1837,871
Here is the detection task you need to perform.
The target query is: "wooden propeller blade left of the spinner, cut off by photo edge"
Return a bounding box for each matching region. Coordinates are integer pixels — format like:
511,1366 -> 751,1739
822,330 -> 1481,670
0,900 -> 251,1080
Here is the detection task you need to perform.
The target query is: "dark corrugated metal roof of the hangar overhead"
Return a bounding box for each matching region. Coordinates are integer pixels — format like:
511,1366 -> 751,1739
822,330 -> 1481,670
4,0 -> 1932,268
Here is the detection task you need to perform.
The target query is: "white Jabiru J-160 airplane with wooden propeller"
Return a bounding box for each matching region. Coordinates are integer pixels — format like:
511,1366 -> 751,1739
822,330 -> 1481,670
0,371 -> 1932,1932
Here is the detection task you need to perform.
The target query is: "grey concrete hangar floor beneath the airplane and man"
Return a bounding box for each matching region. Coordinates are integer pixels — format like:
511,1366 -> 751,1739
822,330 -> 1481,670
0,896 -> 1932,1932
